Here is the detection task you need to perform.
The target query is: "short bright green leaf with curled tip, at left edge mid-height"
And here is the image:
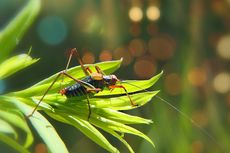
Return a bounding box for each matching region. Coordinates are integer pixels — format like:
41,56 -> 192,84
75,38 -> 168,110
0,54 -> 38,79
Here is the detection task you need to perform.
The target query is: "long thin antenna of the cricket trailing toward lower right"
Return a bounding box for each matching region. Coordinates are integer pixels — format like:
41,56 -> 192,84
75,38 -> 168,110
120,80 -> 224,150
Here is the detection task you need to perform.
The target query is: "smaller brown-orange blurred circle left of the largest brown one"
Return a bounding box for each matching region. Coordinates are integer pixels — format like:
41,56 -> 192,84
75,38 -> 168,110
128,39 -> 146,57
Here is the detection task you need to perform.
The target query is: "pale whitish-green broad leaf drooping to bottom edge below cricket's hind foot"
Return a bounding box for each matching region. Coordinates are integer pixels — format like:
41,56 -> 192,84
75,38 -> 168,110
10,98 -> 68,153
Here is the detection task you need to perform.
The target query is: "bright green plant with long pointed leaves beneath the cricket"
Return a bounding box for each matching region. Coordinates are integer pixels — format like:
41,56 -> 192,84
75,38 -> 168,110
0,0 -> 162,153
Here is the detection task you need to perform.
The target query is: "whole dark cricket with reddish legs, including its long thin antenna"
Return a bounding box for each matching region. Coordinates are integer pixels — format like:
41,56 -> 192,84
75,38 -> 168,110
27,48 -> 221,151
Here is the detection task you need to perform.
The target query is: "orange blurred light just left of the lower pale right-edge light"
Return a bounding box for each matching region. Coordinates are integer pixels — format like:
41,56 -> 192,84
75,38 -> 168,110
188,68 -> 207,86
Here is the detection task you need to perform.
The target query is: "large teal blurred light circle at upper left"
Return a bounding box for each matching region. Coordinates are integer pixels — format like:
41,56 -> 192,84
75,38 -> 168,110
37,16 -> 67,45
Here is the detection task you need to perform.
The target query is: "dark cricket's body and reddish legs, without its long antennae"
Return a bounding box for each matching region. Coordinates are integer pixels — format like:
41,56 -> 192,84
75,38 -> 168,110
28,48 -> 137,120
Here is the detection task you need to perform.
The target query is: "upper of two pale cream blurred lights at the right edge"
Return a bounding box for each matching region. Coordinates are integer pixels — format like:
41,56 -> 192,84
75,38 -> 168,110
217,35 -> 230,59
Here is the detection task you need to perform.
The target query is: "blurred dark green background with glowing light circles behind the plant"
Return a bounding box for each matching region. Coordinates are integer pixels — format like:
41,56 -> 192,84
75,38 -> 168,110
0,0 -> 230,153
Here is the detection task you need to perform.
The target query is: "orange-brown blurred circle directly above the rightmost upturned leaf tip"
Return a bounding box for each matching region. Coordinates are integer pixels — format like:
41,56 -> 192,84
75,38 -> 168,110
133,57 -> 157,79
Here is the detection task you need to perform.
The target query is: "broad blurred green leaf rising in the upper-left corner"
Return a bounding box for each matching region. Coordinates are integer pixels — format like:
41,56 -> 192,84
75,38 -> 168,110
0,0 -> 41,62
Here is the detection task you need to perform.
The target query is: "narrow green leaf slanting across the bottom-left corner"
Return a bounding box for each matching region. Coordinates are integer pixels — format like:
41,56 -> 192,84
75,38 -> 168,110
0,133 -> 29,153
